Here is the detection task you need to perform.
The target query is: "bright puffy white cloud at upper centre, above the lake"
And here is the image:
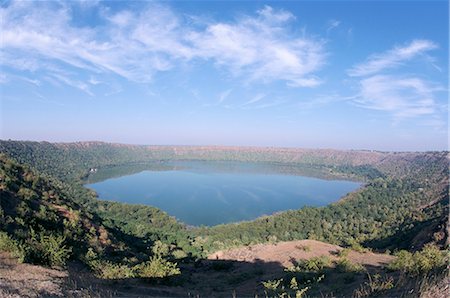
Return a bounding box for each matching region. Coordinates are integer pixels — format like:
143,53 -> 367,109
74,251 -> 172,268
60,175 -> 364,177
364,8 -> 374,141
189,6 -> 326,87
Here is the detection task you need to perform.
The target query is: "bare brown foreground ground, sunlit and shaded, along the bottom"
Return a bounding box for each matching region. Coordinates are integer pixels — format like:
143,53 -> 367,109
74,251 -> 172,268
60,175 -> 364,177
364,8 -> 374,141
0,240 -> 393,297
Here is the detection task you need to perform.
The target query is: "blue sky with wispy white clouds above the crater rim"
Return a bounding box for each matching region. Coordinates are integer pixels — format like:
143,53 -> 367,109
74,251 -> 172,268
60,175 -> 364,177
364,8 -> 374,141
0,1 -> 449,151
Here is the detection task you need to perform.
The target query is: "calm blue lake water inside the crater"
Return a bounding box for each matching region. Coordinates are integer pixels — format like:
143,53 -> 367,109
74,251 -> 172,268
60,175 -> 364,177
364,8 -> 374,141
86,162 -> 361,226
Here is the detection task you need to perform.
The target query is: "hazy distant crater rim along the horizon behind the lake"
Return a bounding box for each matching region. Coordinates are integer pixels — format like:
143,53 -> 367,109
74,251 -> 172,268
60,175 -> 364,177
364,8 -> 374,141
0,140 -> 448,184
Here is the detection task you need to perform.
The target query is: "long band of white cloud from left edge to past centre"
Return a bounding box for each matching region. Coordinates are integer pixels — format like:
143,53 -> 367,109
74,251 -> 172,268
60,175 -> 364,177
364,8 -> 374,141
0,1 -> 326,91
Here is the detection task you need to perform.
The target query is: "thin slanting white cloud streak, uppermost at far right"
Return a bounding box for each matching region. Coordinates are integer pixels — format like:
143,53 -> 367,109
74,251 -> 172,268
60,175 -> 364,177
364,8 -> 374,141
347,39 -> 438,77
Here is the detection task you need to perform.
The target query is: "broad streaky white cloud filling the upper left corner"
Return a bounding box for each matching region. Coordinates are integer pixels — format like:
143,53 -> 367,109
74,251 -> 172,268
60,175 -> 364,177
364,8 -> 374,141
0,3 -> 195,82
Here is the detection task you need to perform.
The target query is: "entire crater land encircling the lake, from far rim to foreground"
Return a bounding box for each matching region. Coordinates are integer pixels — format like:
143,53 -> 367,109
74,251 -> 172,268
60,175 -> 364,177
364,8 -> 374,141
0,141 -> 449,297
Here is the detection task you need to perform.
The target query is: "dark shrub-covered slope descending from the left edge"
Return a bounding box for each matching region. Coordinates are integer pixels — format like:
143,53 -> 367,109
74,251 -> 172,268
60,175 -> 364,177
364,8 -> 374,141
0,155 -> 133,266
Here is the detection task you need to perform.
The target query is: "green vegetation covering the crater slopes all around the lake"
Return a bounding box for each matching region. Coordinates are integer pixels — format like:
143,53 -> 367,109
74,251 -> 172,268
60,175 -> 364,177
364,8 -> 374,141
0,141 -> 449,296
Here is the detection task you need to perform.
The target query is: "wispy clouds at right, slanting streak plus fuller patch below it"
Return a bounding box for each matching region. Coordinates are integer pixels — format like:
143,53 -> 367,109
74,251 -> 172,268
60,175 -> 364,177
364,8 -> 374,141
348,40 -> 445,122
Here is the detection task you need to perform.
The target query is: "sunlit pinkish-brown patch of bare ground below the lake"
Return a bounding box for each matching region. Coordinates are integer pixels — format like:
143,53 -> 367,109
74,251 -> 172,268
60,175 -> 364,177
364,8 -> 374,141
208,240 -> 394,267
